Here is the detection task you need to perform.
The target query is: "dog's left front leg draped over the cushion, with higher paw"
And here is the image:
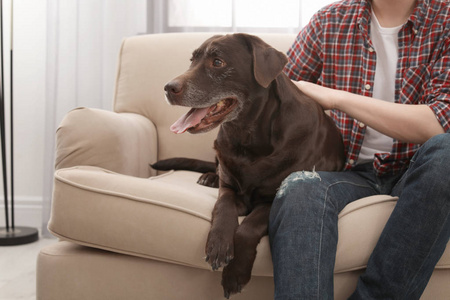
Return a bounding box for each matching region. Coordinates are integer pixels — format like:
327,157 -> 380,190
205,187 -> 238,270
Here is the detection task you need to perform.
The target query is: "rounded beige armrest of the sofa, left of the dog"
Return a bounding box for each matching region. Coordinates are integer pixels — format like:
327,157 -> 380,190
55,108 -> 157,177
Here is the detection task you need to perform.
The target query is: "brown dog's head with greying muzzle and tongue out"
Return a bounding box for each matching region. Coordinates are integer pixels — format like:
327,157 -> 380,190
164,34 -> 287,133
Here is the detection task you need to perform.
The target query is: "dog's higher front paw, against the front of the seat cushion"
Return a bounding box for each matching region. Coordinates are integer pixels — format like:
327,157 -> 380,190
205,232 -> 234,271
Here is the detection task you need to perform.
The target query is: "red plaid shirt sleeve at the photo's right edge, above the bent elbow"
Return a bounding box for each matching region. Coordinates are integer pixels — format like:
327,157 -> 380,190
426,30 -> 450,132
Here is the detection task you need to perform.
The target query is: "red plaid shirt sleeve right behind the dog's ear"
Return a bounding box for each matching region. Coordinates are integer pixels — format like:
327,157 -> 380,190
284,13 -> 322,83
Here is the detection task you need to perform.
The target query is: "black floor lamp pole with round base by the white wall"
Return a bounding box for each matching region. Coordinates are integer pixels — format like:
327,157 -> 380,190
0,0 -> 39,246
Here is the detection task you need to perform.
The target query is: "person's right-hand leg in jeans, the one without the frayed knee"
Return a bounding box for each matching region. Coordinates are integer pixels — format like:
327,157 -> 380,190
350,134 -> 450,299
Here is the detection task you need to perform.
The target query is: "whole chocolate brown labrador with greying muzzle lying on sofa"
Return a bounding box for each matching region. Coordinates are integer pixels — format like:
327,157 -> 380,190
153,34 -> 344,298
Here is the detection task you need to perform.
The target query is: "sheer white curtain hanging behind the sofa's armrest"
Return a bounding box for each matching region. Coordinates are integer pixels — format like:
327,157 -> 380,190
42,0 -> 147,236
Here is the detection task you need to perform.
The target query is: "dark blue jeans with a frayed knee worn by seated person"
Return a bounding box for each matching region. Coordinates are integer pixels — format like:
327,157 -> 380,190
269,134 -> 450,300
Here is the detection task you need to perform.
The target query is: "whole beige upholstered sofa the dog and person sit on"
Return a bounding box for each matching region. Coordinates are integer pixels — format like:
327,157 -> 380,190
37,33 -> 450,300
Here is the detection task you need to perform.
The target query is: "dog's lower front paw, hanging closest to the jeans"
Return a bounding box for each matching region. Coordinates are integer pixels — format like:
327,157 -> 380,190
222,262 -> 251,299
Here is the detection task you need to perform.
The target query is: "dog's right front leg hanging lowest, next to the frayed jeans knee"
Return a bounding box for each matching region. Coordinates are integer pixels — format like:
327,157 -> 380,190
222,203 -> 271,298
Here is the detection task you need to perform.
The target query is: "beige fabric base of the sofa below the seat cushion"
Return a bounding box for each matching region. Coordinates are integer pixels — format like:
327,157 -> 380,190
37,242 -> 450,300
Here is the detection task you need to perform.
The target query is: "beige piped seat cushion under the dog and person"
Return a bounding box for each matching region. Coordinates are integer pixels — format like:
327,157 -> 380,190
48,166 -> 450,276
